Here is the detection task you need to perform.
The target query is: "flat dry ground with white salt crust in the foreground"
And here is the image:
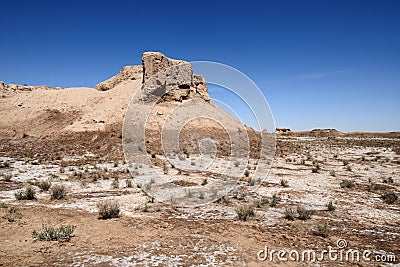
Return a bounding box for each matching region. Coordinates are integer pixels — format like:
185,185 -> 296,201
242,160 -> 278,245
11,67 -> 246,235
0,136 -> 400,266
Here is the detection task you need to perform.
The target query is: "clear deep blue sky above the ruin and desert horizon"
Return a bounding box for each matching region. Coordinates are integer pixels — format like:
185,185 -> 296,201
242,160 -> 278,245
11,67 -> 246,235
0,0 -> 400,131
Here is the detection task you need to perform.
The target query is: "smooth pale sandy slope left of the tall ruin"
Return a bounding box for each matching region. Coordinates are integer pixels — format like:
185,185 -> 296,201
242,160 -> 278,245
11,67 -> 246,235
0,80 -> 142,137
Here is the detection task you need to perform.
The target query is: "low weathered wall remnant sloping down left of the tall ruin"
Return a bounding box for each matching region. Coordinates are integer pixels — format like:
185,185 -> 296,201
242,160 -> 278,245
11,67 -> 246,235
94,66 -> 143,91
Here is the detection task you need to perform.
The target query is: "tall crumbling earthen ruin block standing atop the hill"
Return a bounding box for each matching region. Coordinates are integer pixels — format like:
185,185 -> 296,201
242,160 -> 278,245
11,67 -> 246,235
142,52 -> 210,101
